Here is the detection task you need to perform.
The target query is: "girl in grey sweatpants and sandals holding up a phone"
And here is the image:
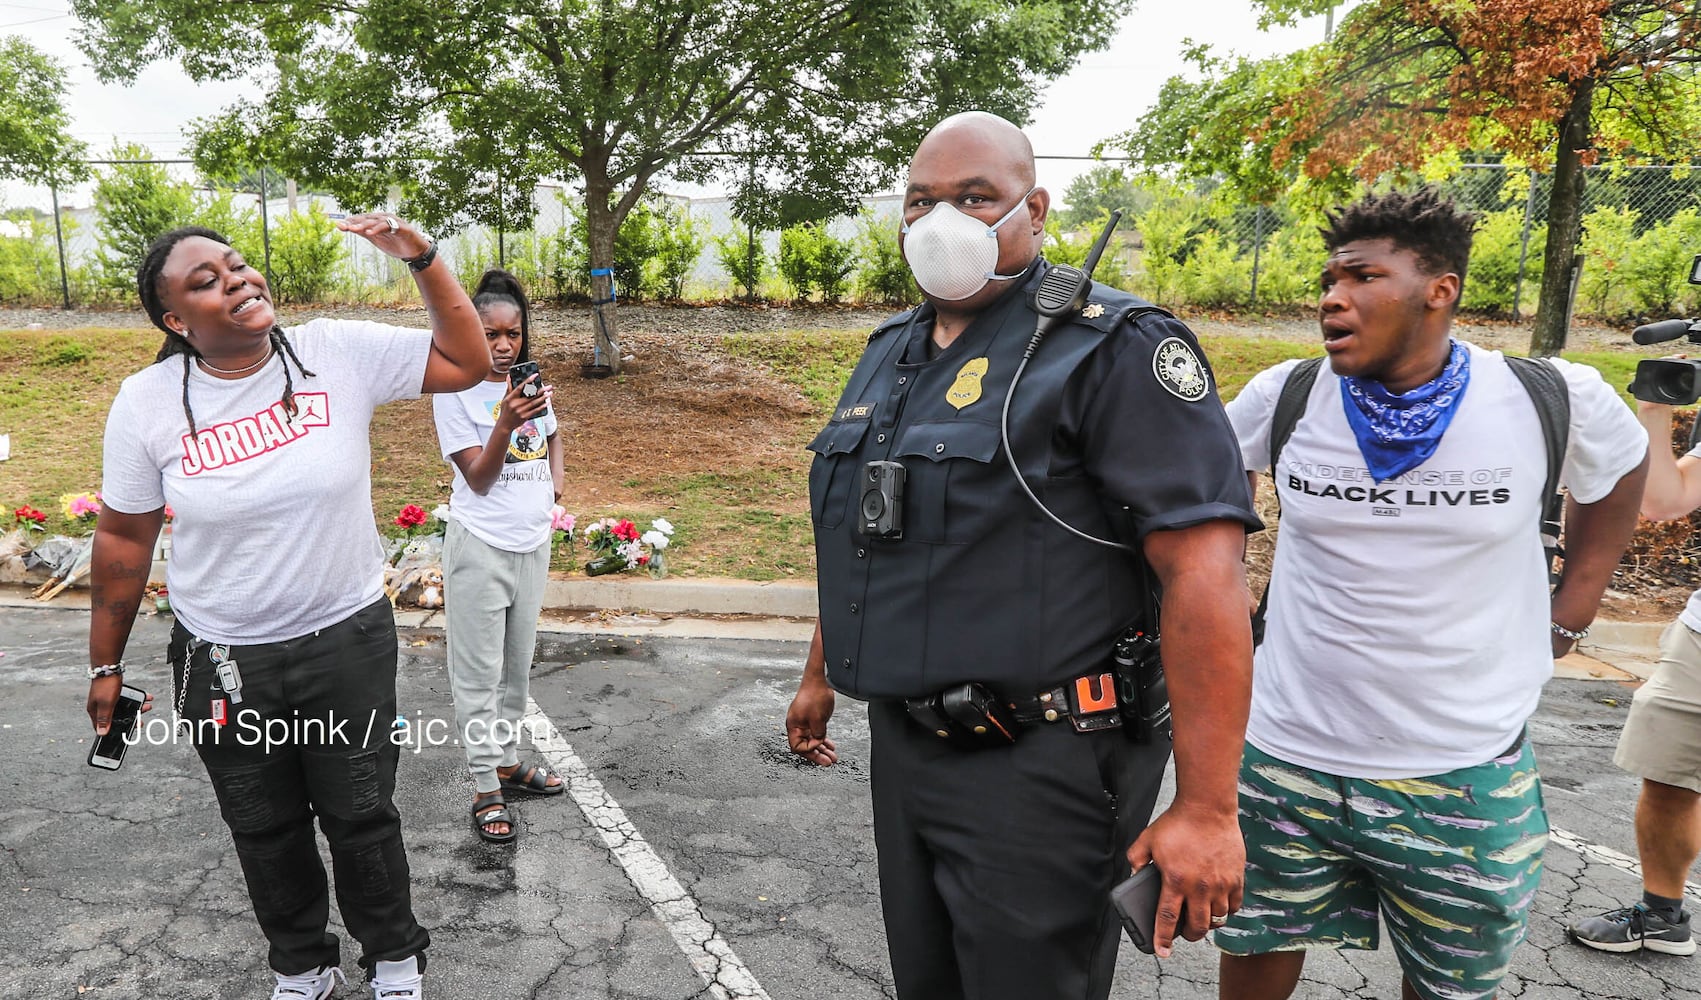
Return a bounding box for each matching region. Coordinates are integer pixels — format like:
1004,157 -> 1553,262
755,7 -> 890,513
432,270 -> 565,844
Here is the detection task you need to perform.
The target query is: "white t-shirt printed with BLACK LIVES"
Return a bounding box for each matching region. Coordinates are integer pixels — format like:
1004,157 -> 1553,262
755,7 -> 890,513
1228,344 -> 1647,777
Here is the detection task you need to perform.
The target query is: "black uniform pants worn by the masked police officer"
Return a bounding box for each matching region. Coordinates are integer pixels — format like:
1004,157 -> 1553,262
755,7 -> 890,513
868,701 -> 1169,1000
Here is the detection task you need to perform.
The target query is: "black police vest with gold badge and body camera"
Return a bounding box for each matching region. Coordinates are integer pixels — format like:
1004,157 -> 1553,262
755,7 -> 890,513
810,262 -> 1150,699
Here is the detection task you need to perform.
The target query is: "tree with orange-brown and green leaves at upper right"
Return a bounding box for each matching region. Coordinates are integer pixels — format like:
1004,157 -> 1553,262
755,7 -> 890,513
1129,0 -> 1701,354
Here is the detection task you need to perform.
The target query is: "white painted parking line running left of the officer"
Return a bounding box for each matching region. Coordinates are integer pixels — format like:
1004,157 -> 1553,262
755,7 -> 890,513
522,699 -> 769,1000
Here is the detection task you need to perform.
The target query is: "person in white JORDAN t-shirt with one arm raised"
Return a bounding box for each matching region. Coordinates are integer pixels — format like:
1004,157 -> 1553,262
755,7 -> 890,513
88,214 -> 488,1000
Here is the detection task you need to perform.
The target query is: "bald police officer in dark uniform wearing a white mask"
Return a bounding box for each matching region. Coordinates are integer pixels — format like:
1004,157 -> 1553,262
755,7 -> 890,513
786,112 -> 1259,1000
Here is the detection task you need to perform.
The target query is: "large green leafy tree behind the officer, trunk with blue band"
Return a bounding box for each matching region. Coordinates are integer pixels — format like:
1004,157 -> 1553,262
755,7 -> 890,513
71,0 -> 1131,374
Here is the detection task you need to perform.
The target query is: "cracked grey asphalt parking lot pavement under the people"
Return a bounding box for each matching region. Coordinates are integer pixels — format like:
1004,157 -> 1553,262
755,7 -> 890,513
0,607 -> 1701,1000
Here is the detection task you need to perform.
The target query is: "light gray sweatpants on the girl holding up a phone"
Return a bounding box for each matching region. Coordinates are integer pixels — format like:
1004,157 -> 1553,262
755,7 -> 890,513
442,520 -> 549,793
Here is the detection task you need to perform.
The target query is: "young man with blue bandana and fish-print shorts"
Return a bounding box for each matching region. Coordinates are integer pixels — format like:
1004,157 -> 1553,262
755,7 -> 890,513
1213,189 -> 1647,1000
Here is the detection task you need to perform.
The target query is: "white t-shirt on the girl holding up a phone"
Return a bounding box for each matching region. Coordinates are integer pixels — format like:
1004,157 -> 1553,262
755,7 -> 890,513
432,381 -> 556,553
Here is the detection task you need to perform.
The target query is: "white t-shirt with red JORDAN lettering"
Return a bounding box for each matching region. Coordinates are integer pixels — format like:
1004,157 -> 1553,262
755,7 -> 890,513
100,320 -> 430,645
